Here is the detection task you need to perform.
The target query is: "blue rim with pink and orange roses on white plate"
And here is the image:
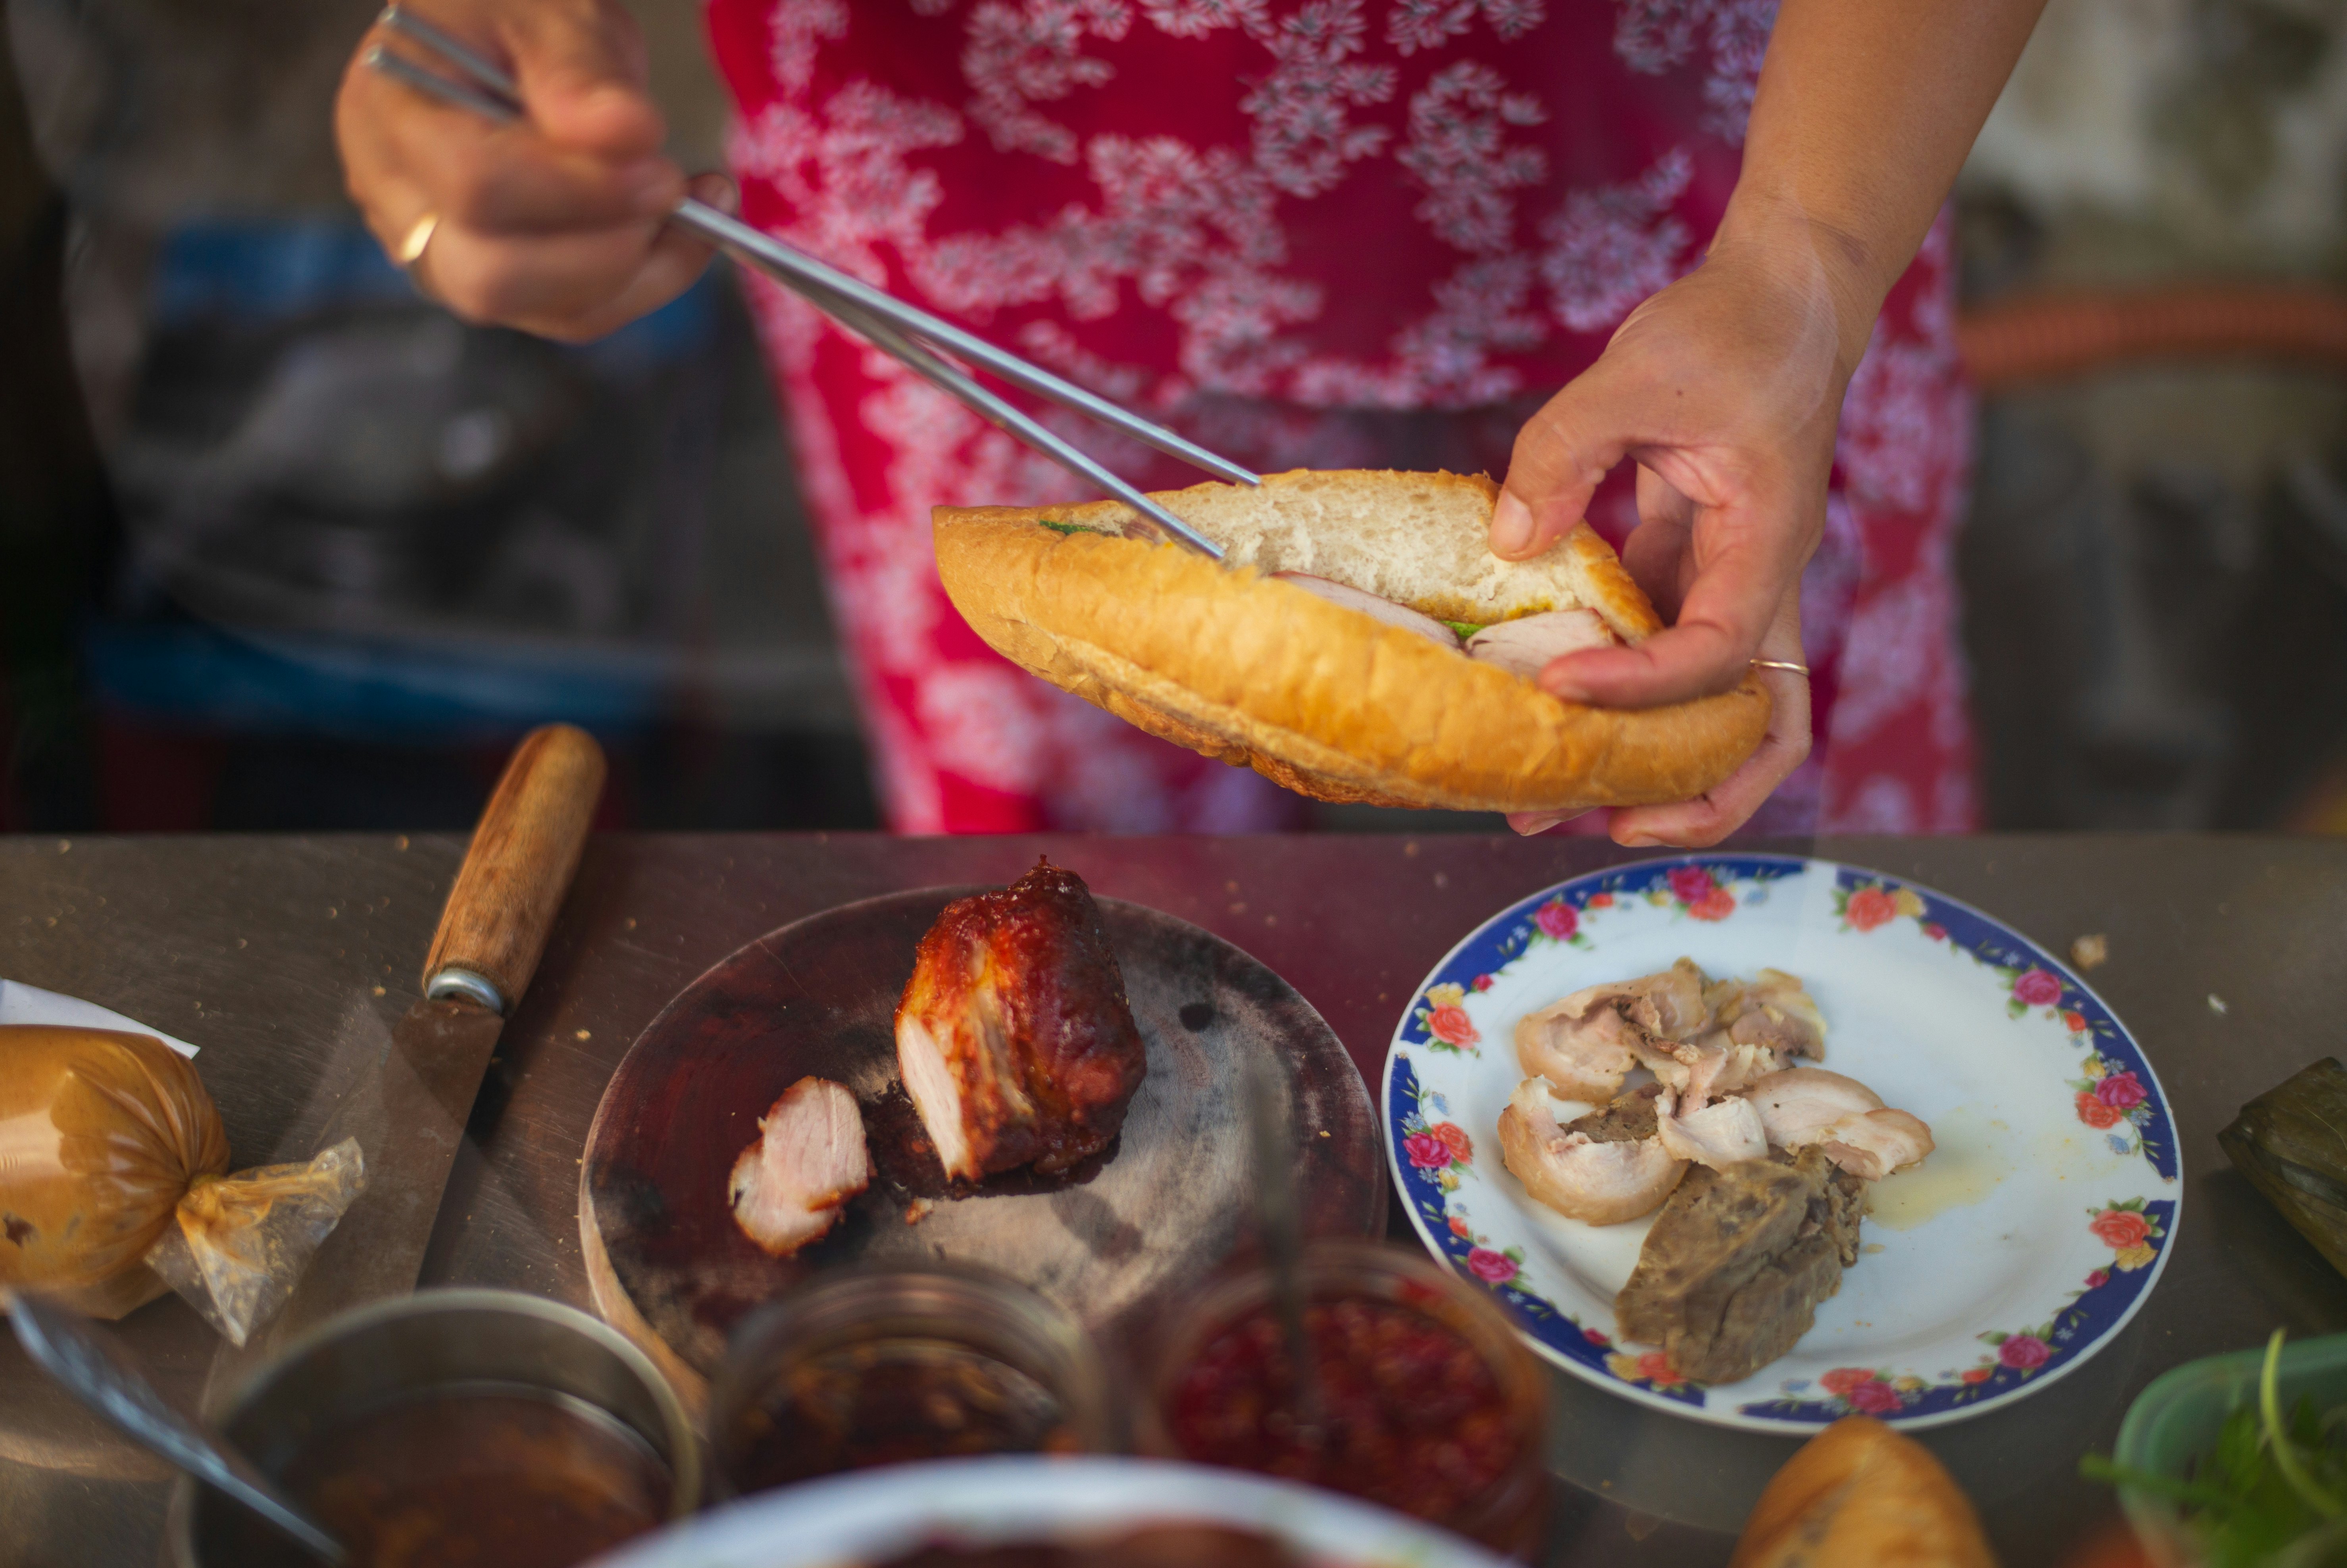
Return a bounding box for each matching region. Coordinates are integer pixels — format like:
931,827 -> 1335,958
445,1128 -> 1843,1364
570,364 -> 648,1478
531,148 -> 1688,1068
1385,854 -> 2178,1429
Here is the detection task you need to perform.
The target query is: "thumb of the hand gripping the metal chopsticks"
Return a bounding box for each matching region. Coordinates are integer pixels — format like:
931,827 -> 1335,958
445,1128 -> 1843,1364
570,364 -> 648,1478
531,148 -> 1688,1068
507,0 -> 669,160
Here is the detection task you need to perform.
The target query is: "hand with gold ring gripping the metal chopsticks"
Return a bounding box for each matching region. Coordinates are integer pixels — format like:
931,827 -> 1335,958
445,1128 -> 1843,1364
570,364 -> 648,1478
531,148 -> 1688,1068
333,0 -> 735,341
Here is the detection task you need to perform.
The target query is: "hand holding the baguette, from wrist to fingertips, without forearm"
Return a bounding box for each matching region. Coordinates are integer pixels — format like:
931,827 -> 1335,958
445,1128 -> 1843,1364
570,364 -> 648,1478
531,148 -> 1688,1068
1490,209 -> 1878,845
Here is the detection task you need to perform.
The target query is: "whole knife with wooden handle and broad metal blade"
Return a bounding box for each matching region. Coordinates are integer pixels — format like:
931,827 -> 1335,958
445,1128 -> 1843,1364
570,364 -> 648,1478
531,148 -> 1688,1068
236,725 -> 603,1350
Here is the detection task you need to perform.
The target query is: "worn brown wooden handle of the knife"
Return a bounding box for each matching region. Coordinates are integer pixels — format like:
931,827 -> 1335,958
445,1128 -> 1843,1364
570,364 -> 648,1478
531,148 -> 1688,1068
425,723 -> 603,1012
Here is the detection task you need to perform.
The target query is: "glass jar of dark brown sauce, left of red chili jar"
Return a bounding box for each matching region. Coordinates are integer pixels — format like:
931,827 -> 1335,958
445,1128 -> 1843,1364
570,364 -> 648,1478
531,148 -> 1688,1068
709,1265 -> 1117,1498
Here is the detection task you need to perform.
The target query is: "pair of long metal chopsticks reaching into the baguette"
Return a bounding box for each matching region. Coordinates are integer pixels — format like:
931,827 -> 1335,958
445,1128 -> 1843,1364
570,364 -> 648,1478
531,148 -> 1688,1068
364,5 -> 1263,561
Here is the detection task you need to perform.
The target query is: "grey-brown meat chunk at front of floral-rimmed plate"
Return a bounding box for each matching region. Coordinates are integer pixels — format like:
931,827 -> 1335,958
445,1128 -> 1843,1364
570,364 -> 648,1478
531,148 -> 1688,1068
1615,1148 -> 1866,1383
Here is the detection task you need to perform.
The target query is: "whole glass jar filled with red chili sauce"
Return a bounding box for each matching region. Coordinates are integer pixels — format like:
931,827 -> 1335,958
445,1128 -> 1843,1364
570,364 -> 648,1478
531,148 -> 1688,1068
1143,1242 -> 1549,1556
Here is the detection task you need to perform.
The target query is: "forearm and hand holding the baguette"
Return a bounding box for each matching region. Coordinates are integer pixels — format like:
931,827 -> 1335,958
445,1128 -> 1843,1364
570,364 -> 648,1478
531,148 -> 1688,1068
1490,0 -> 2044,845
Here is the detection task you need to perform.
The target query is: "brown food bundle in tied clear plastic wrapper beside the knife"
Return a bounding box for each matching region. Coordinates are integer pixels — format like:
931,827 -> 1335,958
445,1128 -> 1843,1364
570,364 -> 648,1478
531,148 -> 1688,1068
0,1026 -> 366,1345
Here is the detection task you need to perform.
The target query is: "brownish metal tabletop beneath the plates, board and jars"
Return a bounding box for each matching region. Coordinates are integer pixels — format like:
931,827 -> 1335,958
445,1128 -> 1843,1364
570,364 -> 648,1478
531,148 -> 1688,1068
0,836 -> 2347,1568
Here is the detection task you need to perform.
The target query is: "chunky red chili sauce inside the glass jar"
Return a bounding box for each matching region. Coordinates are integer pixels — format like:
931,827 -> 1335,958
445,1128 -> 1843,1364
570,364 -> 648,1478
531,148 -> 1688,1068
1166,1298 -> 1523,1519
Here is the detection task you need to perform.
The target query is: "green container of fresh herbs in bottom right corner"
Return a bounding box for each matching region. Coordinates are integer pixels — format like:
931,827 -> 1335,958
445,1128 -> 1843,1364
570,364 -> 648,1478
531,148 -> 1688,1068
2077,1329 -> 2347,1568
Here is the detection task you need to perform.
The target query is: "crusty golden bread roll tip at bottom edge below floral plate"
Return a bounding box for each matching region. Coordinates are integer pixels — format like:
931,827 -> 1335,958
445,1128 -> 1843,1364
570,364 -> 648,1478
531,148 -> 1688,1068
1728,1416 -> 1997,1568
